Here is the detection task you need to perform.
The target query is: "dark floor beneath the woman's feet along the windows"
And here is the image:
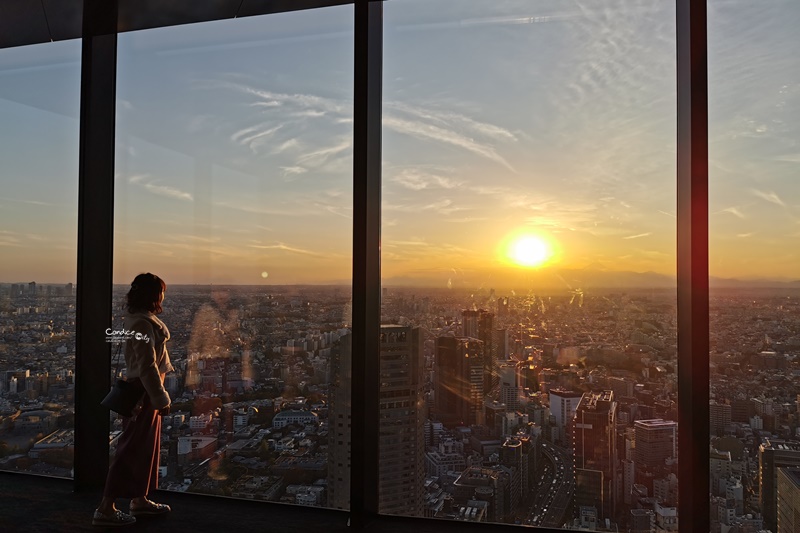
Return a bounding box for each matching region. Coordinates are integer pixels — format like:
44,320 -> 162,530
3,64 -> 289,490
0,472 -> 546,533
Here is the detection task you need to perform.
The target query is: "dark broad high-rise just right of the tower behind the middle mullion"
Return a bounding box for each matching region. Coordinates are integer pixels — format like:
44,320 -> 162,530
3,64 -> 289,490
434,337 -> 484,427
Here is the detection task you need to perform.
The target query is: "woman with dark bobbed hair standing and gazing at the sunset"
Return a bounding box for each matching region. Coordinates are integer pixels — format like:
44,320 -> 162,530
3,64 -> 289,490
92,272 -> 173,526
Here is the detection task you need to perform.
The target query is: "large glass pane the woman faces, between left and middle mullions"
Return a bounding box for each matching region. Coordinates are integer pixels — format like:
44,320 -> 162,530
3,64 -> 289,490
114,7 -> 353,508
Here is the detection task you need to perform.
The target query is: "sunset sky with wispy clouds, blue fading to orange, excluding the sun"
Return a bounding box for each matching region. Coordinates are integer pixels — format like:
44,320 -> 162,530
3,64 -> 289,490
0,0 -> 800,286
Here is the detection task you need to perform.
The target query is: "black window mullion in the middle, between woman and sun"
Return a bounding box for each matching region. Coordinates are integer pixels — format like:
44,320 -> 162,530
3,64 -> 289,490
350,0 -> 383,527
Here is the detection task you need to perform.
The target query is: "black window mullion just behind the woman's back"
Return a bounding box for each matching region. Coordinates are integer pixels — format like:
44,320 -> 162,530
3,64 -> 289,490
74,0 -> 117,490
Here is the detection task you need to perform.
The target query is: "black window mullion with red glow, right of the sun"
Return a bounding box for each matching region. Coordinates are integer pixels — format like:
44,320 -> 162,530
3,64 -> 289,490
676,0 -> 710,533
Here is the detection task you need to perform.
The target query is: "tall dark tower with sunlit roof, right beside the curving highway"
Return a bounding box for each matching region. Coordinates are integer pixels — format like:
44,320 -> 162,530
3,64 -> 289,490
572,390 -> 617,518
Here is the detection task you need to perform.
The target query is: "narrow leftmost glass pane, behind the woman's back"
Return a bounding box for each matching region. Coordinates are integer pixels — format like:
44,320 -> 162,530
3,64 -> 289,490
0,41 -> 80,477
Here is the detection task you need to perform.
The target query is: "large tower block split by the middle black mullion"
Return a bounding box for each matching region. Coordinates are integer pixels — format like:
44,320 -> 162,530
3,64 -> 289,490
328,325 -> 425,516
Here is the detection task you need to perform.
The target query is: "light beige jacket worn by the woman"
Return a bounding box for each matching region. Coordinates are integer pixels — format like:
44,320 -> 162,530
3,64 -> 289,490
125,312 -> 174,409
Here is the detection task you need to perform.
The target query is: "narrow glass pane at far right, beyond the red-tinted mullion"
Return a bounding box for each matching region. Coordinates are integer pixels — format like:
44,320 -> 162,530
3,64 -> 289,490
708,0 -> 800,531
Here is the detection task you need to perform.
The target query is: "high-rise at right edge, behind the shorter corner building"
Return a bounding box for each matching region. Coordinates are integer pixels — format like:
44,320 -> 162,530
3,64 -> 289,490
758,440 -> 800,531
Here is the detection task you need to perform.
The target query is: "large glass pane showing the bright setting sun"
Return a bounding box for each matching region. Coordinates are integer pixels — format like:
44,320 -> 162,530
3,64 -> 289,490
380,0 -> 677,531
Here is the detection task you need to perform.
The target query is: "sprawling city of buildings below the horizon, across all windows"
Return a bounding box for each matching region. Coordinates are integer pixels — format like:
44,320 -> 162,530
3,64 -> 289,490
0,282 -> 800,533
